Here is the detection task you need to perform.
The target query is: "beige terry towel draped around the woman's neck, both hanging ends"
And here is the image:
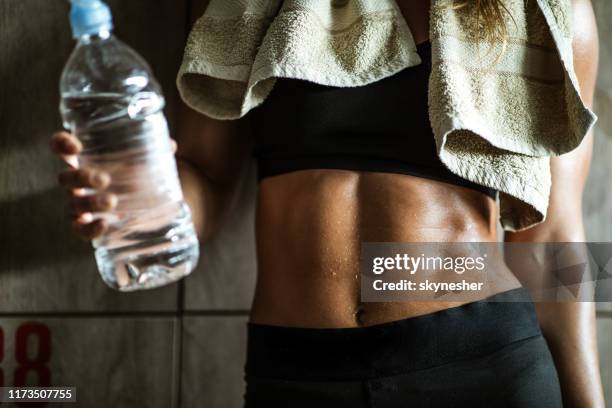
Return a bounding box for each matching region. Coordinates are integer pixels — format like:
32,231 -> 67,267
177,0 -> 596,231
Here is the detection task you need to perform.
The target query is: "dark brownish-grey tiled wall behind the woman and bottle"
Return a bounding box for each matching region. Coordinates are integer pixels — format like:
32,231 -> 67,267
0,0 -> 612,408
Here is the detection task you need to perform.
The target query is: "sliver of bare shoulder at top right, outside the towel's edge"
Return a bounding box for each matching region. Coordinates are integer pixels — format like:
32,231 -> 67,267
571,0 -> 599,105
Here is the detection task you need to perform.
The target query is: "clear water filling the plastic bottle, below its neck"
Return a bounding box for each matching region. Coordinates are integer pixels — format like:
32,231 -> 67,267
62,92 -> 199,291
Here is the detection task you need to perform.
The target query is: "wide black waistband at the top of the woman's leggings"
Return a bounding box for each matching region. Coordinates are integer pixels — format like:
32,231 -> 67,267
246,288 -> 541,381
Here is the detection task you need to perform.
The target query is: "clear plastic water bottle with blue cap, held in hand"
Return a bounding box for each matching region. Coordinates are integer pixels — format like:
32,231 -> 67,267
60,0 -> 199,291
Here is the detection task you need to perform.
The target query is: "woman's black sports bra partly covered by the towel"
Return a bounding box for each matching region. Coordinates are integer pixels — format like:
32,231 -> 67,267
247,42 -> 496,198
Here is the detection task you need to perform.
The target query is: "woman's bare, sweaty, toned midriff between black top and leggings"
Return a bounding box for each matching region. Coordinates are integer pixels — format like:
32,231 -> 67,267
251,170 -> 519,328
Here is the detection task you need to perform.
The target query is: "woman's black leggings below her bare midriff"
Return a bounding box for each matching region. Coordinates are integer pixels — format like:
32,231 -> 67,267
245,288 -> 562,408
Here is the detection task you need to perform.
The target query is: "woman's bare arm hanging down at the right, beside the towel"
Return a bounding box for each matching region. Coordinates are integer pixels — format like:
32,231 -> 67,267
505,0 -> 605,408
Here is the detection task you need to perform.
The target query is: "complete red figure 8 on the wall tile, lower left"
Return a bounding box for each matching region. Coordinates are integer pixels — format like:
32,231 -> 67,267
13,323 -> 51,387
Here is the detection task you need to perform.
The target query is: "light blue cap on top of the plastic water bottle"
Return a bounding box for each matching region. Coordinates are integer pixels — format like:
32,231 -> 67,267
70,0 -> 113,38
